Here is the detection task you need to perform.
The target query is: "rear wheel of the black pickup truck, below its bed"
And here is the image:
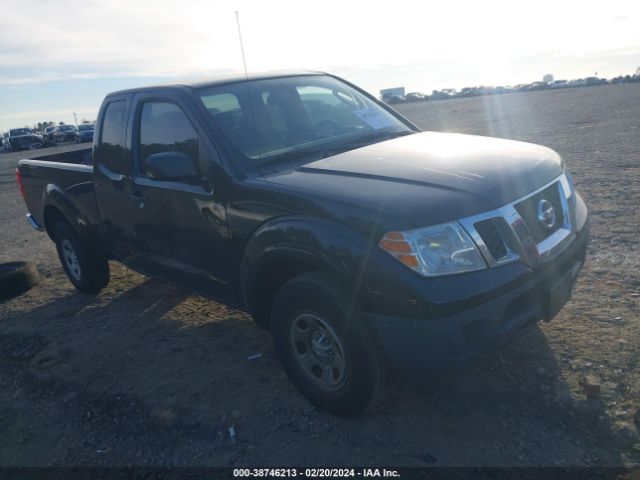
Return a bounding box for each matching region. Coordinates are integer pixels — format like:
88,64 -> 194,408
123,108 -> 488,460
54,221 -> 109,294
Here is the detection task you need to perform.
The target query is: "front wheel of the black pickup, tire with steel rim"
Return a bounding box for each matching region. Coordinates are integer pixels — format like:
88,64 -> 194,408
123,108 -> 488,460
271,272 -> 385,417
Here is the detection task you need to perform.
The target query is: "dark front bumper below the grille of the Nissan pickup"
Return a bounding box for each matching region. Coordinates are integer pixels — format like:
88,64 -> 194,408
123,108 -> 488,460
366,224 -> 589,381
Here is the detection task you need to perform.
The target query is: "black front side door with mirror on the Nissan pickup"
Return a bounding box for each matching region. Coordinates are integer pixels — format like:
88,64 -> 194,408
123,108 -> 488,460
130,95 -> 231,300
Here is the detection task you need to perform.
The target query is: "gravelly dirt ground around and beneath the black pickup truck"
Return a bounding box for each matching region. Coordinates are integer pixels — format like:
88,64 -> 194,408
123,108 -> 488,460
0,84 -> 640,466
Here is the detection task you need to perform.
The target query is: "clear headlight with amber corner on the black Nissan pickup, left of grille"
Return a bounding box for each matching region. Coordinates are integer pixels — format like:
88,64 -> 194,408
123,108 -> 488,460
379,222 -> 487,277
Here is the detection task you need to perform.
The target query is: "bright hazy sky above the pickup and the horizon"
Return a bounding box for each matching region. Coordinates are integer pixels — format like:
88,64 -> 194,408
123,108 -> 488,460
0,0 -> 640,131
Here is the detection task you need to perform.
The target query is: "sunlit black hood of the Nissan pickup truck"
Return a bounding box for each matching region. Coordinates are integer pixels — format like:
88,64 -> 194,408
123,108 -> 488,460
265,132 -> 562,229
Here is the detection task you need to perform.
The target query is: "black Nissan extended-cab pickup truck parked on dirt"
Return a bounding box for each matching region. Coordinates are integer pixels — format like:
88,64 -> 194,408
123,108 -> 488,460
17,73 -> 588,415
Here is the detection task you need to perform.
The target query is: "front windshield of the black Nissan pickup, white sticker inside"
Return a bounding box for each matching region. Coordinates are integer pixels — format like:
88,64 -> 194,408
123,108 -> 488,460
199,75 -> 413,164
